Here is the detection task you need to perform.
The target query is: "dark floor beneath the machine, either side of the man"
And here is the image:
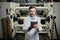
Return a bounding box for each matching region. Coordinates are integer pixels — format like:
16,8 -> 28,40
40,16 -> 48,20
0,33 -> 57,40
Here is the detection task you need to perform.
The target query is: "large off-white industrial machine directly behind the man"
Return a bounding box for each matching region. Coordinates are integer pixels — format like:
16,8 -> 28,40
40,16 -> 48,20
14,3 -> 53,38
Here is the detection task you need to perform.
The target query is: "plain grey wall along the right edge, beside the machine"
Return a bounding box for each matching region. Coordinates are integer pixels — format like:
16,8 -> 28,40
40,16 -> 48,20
53,2 -> 60,38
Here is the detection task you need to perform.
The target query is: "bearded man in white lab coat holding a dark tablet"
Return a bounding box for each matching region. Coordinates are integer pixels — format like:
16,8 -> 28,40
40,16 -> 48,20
22,6 -> 42,40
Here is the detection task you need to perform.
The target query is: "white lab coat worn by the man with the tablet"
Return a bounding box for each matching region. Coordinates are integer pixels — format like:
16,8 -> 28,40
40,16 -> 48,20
23,15 -> 42,40
